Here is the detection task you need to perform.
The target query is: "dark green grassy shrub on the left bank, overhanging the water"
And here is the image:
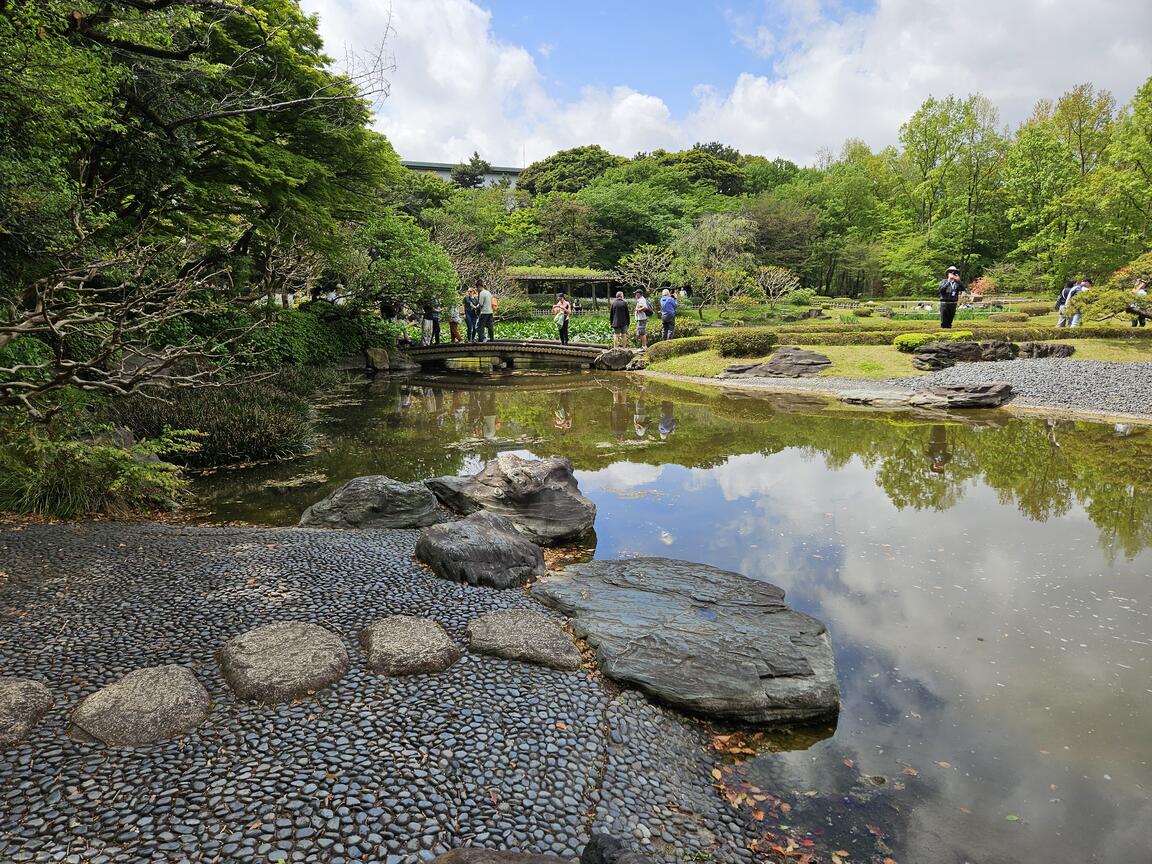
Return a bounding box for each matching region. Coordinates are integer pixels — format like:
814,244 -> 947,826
107,381 -> 314,468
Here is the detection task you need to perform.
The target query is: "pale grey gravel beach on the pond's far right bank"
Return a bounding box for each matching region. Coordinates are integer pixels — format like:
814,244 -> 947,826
654,358 -> 1152,418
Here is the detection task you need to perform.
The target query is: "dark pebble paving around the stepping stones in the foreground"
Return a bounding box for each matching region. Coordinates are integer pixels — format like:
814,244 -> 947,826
0,523 -> 752,864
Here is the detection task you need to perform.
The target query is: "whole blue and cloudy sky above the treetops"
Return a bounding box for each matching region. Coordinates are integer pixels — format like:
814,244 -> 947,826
302,0 -> 1152,167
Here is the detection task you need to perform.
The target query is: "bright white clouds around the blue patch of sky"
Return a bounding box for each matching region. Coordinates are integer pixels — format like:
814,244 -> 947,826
304,0 -> 1152,165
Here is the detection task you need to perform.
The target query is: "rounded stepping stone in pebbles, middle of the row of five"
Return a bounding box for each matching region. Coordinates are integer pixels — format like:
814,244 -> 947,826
217,621 -> 349,704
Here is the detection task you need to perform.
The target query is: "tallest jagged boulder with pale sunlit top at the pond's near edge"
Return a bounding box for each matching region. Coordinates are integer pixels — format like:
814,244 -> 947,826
427,453 -> 596,546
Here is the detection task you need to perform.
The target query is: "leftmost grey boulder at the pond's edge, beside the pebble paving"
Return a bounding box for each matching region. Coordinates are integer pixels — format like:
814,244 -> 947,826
300,475 -> 442,528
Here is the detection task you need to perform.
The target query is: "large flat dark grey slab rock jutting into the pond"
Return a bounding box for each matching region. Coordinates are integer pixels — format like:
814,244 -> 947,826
531,558 -> 840,723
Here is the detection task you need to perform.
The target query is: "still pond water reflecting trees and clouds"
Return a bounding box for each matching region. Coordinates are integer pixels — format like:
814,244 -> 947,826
198,373 -> 1152,864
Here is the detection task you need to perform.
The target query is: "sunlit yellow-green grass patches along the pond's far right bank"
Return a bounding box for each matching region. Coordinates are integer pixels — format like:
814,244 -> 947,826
650,339 -> 1152,378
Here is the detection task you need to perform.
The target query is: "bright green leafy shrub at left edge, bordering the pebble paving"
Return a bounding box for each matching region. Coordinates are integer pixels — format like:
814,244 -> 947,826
0,426 -> 195,518
